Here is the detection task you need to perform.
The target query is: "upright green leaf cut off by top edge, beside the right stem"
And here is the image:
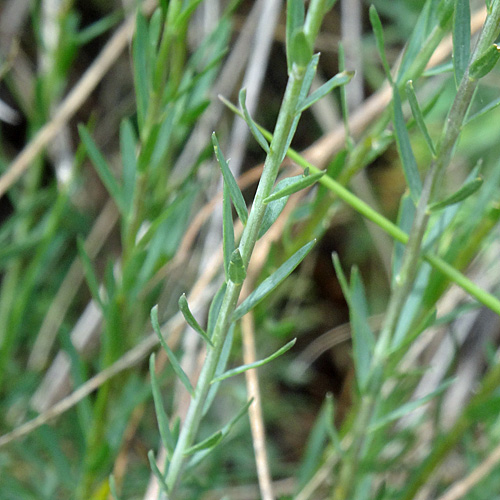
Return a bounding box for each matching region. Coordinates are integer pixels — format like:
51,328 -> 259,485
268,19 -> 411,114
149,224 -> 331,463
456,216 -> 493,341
453,0 -> 470,87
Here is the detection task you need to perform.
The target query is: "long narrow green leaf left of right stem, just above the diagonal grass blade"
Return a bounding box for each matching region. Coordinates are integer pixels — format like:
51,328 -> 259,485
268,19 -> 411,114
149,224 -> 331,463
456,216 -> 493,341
393,87 -> 422,205
